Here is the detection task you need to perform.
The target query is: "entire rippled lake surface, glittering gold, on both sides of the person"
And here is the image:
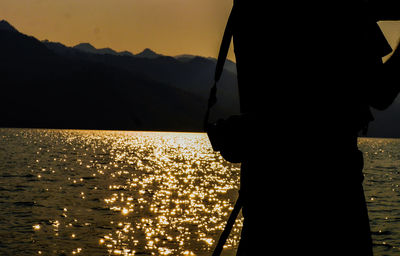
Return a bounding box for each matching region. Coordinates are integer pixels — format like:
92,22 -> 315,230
0,129 -> 400,255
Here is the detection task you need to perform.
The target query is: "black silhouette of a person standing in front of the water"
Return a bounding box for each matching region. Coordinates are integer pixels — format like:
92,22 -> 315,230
210,0 -> 400,255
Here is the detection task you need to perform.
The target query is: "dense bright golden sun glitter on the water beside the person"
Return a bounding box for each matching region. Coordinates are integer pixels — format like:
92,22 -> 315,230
100,133 -> 241,255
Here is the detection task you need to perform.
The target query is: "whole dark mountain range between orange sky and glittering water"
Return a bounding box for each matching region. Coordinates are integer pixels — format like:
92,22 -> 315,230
0,22 -> 238,131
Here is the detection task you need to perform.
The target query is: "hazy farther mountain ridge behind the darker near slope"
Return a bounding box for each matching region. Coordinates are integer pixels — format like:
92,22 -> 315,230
43,38 -> 239,114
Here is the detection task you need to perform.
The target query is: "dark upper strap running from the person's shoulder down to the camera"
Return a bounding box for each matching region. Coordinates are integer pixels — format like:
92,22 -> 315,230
203,5 -> 235,131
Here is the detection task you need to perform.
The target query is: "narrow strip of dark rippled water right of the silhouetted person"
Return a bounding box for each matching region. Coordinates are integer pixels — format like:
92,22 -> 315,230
359,138 -> 400,256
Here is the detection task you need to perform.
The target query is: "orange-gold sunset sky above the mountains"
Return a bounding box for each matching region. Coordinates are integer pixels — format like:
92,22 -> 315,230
0,0 -> 400,59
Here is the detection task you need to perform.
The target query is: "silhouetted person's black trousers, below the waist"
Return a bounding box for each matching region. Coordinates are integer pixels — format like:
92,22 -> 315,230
237,150 -> 373,256
